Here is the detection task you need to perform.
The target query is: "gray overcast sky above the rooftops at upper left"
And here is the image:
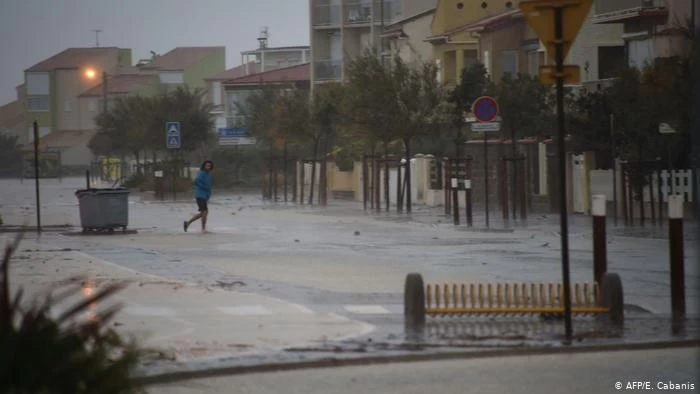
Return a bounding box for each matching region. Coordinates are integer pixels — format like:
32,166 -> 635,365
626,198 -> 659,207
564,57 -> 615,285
0,0 -> 309,105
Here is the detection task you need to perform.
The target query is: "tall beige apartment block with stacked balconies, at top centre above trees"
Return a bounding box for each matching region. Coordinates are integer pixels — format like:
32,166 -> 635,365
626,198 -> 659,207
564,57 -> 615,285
309,0 -> 436,89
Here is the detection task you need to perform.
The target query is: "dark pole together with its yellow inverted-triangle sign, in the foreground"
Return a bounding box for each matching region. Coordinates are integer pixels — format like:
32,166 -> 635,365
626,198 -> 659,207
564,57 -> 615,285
520,0 -> 593,343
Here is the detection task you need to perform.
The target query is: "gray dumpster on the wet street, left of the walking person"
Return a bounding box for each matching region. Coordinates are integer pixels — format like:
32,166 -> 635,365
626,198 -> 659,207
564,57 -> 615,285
75,188 -> 129,232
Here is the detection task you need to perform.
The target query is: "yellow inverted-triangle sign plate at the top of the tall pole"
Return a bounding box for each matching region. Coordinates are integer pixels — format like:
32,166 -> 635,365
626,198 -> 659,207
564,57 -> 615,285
520,0 -> 593,59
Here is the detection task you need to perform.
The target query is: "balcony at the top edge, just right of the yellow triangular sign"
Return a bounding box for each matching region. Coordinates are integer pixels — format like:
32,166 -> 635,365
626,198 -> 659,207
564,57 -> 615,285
593,0 -> 668,23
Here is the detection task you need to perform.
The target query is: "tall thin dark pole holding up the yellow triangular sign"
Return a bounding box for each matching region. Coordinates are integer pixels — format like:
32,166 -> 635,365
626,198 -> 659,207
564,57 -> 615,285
554,6 -> 573,343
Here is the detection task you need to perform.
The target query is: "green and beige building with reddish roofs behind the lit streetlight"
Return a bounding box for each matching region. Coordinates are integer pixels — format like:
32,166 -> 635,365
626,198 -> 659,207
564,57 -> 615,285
18,47 -> 225,166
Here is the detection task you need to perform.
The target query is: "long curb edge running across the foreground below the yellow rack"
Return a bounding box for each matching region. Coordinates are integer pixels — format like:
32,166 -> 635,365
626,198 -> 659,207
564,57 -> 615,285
134,339 -> 700,385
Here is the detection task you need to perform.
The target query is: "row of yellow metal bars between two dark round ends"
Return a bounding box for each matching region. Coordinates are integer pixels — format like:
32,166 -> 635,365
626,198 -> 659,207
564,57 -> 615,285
425,283 -> 610,316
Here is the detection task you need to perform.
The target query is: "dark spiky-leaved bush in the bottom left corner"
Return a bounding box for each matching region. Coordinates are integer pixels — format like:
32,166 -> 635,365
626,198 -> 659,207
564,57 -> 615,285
0,237 -> 144,394
